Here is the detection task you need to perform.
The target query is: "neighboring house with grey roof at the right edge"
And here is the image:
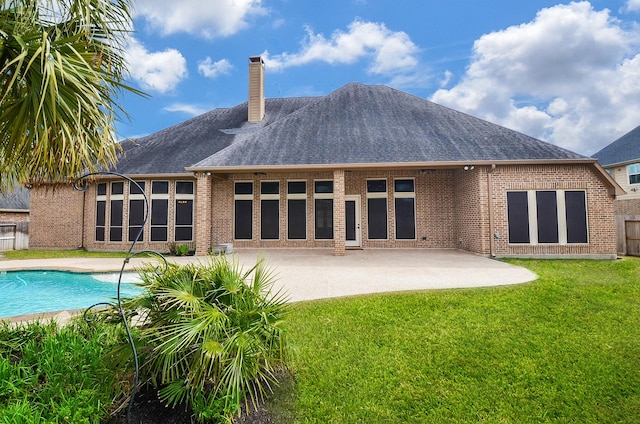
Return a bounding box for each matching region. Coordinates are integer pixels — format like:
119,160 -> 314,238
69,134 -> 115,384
592,126 -> 640,256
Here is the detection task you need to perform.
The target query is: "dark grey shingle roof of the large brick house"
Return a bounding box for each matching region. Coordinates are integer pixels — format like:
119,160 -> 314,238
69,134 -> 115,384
117,83 -> 586,174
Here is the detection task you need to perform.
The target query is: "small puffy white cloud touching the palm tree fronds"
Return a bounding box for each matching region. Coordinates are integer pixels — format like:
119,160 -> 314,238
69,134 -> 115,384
125,39 -> 187,93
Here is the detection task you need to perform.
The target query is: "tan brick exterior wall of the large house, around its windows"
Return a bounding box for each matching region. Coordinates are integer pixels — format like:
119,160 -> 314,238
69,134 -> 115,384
32,165 -> 616,257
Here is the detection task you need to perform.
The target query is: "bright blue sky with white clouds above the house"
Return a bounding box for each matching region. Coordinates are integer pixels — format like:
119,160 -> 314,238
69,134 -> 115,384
117,0 -> 640,155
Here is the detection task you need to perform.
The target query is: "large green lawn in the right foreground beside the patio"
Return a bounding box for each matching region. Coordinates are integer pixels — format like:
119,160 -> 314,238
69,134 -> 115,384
270,259 -> 640,423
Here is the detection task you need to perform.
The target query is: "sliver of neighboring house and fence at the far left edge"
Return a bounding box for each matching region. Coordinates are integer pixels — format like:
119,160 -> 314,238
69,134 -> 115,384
0,187 -> 29,251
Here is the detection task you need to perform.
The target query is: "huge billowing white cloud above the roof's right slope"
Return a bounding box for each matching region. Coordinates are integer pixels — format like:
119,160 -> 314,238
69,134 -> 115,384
432,2 -> 640,154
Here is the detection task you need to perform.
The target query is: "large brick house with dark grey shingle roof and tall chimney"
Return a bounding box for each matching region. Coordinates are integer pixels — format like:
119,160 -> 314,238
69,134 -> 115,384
31,56 -> 620,258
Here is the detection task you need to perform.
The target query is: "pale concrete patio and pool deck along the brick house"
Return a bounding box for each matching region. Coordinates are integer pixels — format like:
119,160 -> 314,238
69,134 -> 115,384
0,249 -> 537,302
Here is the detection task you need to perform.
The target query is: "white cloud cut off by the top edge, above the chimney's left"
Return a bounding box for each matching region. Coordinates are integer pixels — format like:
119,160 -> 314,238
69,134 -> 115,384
134,0 -> 266,38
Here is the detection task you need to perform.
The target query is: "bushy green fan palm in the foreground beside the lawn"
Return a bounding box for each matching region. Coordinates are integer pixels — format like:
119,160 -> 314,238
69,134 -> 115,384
120,256 -> 288,419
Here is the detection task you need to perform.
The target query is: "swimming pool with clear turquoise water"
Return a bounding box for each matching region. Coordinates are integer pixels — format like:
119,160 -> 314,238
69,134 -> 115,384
0,271 -> 142,318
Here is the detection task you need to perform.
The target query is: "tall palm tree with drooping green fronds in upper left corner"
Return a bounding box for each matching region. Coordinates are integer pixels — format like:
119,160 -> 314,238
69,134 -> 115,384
0,0 -> 143,191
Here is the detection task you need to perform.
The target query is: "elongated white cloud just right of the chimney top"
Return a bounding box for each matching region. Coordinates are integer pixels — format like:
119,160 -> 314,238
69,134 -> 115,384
263,20 -> 419,75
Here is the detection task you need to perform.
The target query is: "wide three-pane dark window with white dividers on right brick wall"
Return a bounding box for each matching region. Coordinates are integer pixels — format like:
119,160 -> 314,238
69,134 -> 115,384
507,190 -> 588,244
